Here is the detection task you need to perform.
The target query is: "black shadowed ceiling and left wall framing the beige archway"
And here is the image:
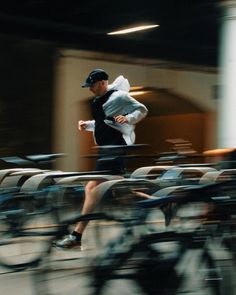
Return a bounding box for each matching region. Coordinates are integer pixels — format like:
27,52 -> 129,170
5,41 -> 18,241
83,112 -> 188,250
0,0 -> 222,156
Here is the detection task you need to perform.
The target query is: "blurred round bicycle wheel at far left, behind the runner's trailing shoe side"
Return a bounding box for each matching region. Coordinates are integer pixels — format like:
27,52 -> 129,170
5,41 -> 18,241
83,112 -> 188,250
0,196 -> 57,270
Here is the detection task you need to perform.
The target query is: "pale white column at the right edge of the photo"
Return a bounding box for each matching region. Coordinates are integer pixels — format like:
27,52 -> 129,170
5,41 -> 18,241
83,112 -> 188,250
217,0 -> 236,148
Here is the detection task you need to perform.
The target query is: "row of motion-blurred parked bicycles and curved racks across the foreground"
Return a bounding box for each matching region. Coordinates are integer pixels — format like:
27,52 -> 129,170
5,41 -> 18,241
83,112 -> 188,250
0,151 -> 236,294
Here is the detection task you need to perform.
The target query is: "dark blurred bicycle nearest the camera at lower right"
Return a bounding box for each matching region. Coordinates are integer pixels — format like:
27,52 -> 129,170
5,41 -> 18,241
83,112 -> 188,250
87,178 -> 235,295
